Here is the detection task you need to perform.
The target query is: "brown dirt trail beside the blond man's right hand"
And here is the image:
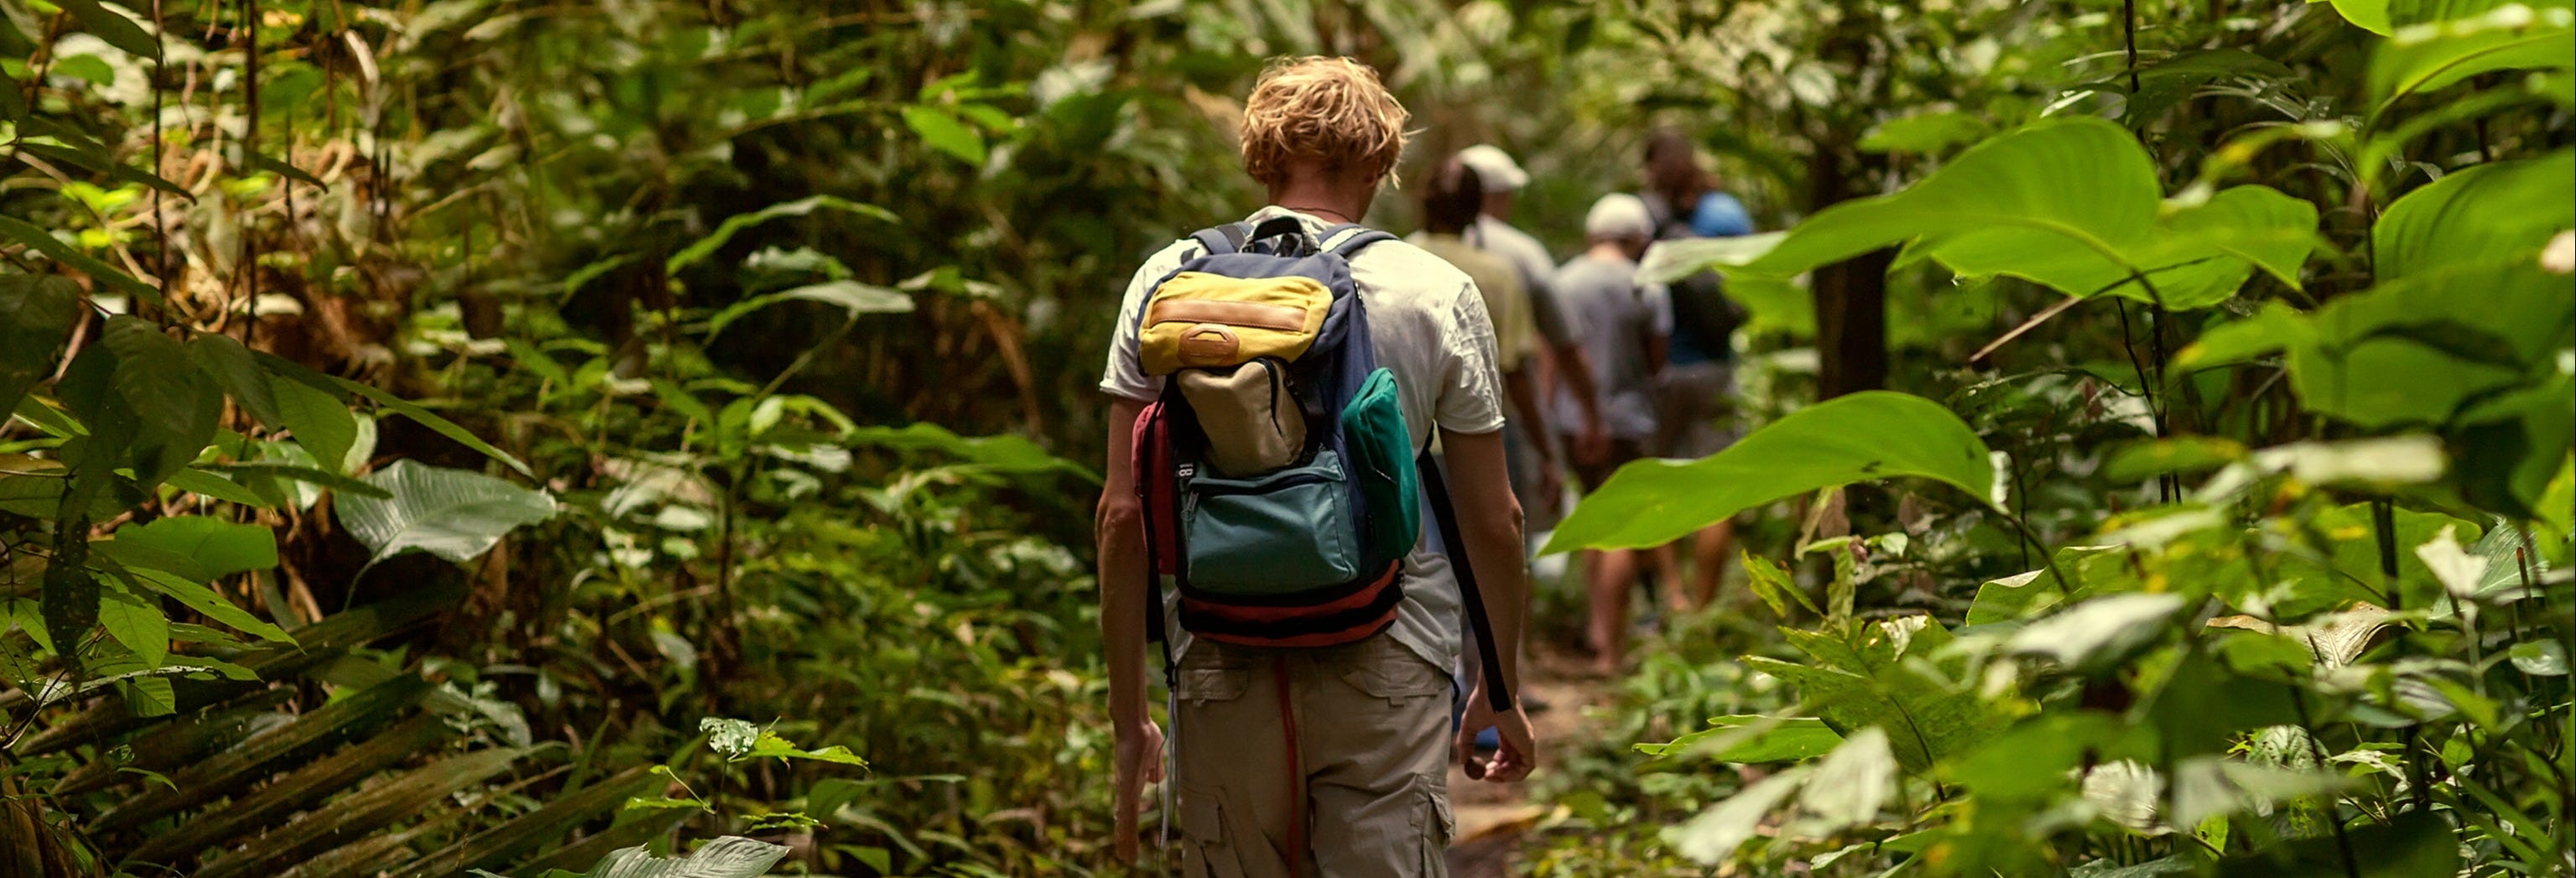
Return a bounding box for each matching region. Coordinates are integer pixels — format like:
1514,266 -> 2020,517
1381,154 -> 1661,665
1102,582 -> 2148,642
1448,649 -> 1616,878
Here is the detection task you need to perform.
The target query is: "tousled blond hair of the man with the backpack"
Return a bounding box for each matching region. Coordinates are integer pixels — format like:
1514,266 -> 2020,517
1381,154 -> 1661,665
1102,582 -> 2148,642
1241,54 -> 1412,185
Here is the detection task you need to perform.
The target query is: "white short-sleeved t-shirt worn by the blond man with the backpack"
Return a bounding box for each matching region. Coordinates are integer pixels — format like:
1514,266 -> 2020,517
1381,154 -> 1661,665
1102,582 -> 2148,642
1100,206 -> 1501,667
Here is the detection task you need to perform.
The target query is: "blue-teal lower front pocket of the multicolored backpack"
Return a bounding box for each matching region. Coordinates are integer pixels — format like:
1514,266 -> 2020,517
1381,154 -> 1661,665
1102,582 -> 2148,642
1183,448 -> 1368,595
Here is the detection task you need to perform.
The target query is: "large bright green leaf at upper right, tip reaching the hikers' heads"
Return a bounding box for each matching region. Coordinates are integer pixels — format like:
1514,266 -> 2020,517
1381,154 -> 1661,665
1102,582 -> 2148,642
1646,118 -> 2316,309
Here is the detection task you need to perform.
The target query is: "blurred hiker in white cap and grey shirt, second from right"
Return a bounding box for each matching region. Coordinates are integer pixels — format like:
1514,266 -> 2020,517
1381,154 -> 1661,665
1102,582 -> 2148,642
1553,193 -> 1672,672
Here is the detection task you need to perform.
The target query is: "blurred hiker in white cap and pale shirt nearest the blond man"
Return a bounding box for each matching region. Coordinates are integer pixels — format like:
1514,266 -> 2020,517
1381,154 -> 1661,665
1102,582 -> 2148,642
1458,144 -> 1607,491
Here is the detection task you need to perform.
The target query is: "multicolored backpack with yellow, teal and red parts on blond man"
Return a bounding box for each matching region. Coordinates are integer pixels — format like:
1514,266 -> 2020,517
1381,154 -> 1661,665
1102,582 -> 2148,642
1133,216 -> 1507,708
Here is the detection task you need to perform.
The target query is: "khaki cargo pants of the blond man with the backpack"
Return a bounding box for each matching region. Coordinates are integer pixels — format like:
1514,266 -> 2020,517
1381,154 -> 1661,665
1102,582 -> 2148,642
1172,633 -> 1453,878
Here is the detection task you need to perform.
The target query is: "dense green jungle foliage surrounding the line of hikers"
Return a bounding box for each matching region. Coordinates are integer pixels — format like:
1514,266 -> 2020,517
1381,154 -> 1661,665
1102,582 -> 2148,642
0,0 -> 2576,878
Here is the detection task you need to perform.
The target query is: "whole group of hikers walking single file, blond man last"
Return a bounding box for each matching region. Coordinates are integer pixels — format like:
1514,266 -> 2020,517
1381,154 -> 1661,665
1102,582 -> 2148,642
1097,57 -> 1749,878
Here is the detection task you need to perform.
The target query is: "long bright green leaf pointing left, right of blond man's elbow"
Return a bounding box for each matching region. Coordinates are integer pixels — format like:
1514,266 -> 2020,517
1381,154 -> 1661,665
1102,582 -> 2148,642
1543,392 -> 1994,553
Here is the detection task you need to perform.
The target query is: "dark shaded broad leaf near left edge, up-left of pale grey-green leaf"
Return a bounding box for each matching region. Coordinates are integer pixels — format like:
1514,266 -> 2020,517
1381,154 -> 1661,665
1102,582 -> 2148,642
54,314 -> 224,495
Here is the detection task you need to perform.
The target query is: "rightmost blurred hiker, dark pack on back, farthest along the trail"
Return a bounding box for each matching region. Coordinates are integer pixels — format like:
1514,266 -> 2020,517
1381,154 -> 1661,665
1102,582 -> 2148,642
1643,129 -> 1754,610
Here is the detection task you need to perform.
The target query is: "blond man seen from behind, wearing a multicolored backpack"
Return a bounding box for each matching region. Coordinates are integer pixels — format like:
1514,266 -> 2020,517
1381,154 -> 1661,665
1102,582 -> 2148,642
1097,57 -> 1538,878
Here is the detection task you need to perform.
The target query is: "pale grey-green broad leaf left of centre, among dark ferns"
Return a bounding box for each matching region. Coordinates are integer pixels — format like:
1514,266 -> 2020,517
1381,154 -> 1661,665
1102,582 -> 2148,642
337,461 -> 554,564
